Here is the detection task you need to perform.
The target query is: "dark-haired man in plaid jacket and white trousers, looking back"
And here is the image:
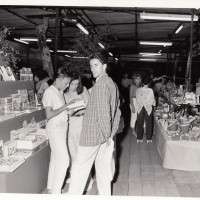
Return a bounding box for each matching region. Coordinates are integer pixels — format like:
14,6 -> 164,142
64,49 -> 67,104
68,54 -> 121,195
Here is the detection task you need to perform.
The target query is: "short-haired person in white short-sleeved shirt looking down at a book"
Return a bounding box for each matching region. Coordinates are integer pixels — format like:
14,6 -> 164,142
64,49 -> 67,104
42,68 -> 72,194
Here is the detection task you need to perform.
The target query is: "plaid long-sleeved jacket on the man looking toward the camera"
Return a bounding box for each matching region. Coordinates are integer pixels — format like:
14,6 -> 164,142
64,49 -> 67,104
79,73 -> 121,146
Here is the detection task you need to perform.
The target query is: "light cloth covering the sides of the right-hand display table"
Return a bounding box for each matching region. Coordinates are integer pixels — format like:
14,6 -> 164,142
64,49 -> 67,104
154,116 -> 200,171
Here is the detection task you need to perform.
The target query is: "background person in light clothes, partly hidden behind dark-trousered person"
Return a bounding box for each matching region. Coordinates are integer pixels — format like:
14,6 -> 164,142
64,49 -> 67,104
129,74 -> 142,136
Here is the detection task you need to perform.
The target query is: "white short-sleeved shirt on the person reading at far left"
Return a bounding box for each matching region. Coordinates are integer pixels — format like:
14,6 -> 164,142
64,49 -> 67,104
42,85 -> 68,128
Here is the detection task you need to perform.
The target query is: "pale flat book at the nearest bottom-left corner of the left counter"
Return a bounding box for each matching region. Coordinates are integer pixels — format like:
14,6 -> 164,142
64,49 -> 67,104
0,157 -> 25,172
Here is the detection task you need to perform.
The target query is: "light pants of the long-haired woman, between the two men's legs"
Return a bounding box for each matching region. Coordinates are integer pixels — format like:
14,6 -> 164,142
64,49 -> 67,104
68,116 -> 83,170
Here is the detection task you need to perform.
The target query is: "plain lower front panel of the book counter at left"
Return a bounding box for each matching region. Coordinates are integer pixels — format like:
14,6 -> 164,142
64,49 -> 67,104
0,144 -> 50,194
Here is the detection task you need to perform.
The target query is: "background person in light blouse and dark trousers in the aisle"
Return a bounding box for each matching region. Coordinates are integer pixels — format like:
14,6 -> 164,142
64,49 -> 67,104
136,77 -> 155,143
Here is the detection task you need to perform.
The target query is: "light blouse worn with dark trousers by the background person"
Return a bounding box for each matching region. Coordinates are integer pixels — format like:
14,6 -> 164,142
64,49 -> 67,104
136,87 -> 155,115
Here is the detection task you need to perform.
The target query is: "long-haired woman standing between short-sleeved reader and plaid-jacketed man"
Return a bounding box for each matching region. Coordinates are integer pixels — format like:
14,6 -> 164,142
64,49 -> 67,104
65,72 -> 93,191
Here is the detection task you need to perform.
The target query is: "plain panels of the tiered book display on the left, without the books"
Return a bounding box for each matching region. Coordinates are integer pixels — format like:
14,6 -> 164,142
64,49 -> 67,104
0,81 -> 50,193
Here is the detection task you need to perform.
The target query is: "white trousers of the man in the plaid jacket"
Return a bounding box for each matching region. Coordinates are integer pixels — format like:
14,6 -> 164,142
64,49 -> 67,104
68,143 -> 111,195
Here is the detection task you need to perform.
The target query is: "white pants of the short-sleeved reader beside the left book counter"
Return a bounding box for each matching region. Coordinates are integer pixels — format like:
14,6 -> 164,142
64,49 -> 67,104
47,126 -> 69,194
